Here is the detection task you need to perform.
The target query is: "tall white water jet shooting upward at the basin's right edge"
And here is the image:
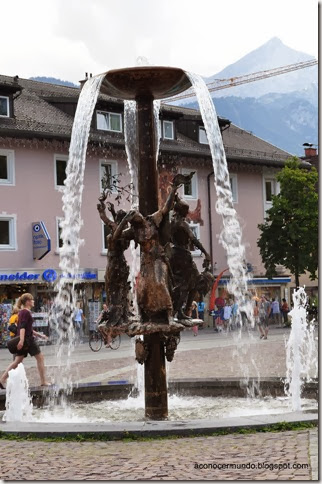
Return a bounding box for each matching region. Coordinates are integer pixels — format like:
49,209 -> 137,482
285,287 -> 318,411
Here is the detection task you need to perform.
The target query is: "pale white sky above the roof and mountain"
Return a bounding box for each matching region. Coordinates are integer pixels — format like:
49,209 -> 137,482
0,0 -> 321,83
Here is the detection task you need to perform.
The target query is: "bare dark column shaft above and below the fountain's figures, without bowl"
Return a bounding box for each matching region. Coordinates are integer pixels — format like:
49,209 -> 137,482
135,96 -> 168,420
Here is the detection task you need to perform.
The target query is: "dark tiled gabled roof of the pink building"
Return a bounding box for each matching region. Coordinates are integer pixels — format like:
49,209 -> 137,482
0,75 -> 304,164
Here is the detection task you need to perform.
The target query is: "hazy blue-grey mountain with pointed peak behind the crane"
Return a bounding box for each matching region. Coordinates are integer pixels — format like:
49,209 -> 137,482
180,37 -> 318,156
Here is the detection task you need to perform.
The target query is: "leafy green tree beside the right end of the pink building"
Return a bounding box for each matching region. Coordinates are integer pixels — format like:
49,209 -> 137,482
257,157 -> 318,287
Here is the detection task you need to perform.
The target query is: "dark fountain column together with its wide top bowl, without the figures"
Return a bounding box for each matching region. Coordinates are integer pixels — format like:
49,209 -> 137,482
101,67 -> 191,420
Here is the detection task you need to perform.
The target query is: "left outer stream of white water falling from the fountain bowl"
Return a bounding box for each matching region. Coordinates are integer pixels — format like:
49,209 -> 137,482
50,75 -> 104,395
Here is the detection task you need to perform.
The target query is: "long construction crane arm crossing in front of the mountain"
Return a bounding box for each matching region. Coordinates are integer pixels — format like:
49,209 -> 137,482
167,59 -> 318,103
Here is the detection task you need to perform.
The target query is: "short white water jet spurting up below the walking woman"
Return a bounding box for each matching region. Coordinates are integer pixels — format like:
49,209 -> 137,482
3,363 -> 33,422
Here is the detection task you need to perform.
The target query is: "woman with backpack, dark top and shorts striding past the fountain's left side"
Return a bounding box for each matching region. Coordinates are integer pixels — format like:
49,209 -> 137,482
0,293 -> 49,389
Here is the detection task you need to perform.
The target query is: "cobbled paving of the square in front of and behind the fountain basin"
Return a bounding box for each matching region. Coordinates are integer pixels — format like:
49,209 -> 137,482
0,328 -> 318,481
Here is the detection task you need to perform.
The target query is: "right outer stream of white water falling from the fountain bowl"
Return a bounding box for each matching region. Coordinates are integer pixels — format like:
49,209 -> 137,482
186,72 -> 260,395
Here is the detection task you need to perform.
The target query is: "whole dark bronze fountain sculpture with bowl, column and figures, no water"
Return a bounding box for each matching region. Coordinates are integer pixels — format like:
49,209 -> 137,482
97,67 -> 213,420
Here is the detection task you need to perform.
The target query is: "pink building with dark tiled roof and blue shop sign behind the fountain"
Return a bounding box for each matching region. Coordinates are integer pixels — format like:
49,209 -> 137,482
0,76 -> 310,332
